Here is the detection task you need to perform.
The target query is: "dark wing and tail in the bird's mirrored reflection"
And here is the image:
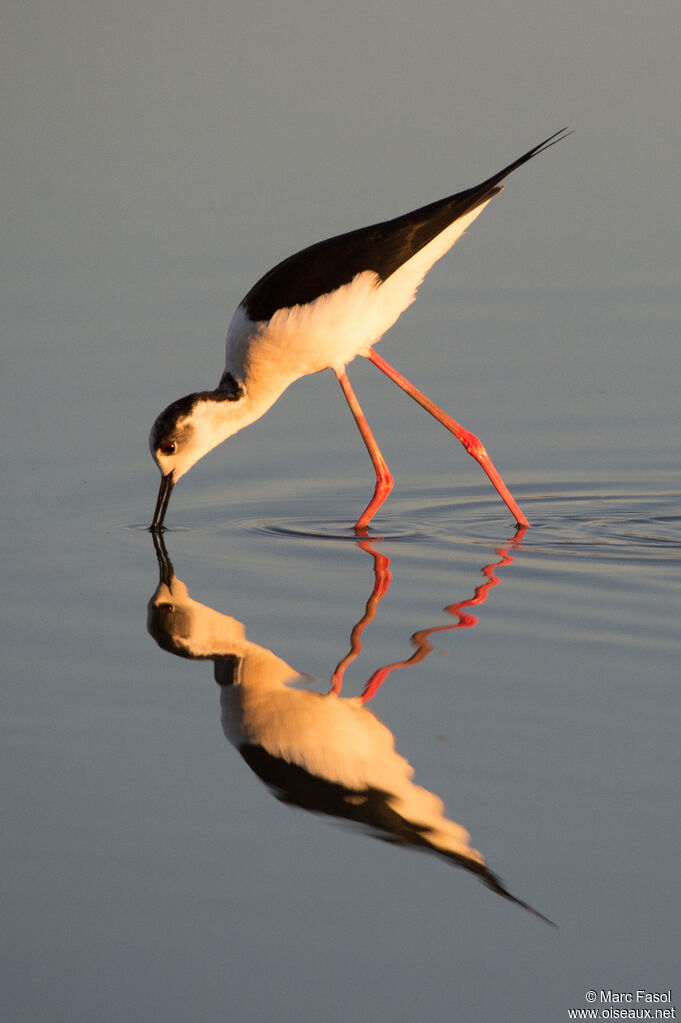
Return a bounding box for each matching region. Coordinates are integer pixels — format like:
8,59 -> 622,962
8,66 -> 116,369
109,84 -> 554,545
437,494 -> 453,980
238,744 -> 555,927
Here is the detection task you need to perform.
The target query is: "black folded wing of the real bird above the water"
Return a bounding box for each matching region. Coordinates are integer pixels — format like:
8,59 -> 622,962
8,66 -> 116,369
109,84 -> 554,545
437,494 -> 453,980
241,129 -> 564,321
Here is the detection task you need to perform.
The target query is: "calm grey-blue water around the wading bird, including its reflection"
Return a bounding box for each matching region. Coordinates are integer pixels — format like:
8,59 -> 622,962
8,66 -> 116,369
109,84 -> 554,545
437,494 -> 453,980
0,4 -> 681,1023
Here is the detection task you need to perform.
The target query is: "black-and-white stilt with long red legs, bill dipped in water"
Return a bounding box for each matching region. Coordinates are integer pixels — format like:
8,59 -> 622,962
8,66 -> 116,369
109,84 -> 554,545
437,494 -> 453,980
149,128 -> 569,533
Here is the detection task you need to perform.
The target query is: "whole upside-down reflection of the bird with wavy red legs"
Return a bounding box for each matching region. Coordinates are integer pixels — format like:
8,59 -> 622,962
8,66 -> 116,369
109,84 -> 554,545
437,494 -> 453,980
147,535 -> 551,923
